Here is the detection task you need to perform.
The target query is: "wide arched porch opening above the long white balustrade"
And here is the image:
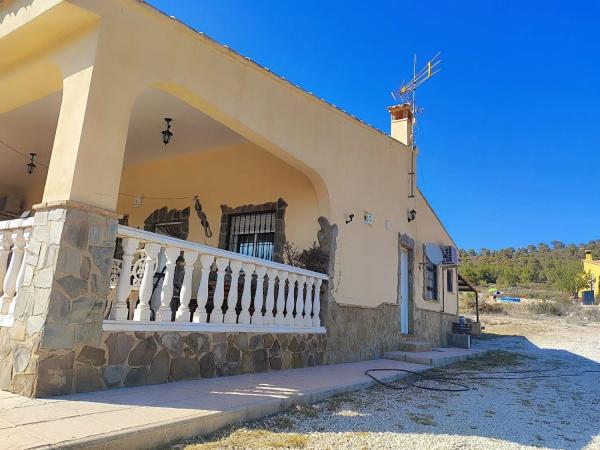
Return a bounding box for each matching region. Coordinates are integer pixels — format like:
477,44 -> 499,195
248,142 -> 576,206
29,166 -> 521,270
117,87 -> 328,262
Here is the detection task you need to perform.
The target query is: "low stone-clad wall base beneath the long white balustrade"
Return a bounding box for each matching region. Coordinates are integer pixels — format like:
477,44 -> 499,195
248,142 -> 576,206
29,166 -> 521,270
39,332 -> 325,395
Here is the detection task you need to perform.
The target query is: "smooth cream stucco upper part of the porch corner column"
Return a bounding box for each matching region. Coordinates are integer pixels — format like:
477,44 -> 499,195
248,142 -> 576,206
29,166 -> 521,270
43,33 -> 139,211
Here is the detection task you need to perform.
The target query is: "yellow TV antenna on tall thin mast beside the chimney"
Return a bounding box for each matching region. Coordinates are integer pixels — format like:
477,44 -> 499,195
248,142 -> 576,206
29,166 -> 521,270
392,52 -> 442,198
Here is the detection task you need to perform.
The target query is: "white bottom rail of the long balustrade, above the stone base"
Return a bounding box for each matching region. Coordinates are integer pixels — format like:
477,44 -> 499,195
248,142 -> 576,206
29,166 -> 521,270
102,320 -> 325,334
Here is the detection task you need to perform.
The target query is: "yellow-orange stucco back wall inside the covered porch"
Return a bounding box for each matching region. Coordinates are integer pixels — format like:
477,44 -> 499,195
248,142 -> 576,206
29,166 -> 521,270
117,143 -> 319,249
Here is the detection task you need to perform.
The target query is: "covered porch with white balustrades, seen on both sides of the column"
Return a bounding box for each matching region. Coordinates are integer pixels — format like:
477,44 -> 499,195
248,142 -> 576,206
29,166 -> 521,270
0,81 -> 327,333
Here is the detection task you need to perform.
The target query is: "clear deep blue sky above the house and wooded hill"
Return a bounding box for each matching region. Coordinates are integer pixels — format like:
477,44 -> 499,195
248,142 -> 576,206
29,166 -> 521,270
150,0 -> 600,248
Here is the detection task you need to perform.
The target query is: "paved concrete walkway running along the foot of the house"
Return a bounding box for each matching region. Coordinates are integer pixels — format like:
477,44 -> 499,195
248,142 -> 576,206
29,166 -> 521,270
0,350 -> 486,449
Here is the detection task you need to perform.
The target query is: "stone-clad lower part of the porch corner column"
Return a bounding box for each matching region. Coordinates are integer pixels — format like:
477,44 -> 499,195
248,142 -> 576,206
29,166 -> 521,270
0,204 -> 116,396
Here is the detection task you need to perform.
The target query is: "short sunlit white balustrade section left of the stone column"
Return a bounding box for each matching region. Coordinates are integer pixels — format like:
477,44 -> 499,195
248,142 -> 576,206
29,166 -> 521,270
0,217 -> 33,326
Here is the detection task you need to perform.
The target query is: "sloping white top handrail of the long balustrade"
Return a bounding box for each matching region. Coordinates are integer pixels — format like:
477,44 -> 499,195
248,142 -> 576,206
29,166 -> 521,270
117,225 -> 329,280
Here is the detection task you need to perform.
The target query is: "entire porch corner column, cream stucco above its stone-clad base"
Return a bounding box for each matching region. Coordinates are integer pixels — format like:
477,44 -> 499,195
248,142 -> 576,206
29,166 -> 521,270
0,31 -> 138,397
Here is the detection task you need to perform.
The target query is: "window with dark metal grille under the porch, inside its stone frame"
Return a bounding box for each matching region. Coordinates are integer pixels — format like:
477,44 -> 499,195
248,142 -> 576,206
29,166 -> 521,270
227,211 -> 275,260
